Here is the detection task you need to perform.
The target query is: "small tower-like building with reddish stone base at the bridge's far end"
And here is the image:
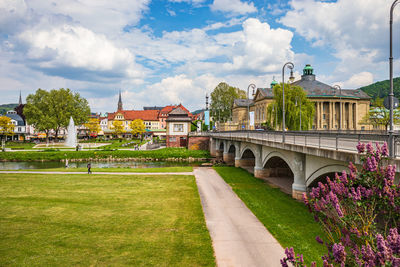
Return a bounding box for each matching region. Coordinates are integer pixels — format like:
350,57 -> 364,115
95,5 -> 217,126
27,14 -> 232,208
166,107 -> 192,147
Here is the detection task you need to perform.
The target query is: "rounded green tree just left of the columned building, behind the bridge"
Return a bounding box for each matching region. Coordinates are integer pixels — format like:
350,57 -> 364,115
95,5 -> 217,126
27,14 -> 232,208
210,82 -> 246,121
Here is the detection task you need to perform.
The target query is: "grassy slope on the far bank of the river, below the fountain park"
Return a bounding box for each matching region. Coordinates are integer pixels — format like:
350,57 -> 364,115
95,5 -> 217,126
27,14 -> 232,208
0,148 -> 210,161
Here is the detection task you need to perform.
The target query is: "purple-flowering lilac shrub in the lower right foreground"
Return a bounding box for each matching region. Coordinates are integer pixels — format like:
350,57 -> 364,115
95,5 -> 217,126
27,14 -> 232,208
281,143 -> 400,267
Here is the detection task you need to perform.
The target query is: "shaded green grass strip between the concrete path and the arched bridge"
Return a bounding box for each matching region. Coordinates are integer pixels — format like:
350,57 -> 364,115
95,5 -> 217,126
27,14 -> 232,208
214,167 -> 325,265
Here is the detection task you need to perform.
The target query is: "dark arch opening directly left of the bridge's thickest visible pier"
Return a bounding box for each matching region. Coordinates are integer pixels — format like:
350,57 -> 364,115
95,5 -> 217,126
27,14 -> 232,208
263,156 -> 294,194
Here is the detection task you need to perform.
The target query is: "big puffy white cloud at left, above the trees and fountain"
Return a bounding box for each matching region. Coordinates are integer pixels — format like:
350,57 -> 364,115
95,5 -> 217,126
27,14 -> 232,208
18,21 -> 147,81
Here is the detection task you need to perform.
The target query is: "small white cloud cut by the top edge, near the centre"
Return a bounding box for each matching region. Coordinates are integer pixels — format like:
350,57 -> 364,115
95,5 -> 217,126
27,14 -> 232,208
210,0 -> 257,15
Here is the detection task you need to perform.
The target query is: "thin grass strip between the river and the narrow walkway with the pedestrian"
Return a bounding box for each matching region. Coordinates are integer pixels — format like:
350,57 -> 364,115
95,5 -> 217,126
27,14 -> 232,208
0,166 -> 193,173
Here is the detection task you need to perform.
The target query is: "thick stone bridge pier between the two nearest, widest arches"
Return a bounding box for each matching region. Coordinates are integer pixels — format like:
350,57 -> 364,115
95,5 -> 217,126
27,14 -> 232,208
292,153 -> 307,199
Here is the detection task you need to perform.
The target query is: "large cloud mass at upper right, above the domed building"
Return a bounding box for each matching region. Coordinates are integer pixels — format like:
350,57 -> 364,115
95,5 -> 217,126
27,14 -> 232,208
280,0 -> 400,79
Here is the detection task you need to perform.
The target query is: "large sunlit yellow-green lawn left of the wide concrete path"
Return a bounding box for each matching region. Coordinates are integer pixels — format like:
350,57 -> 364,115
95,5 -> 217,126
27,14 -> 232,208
0,174 -> 215,266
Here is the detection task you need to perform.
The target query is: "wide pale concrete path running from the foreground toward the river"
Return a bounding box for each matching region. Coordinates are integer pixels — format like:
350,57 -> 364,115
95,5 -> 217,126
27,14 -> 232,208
194,168 -> 284,267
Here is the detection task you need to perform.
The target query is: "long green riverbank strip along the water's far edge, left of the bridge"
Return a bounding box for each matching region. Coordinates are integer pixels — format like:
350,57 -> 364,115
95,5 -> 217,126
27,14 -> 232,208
0,148 -> 210,162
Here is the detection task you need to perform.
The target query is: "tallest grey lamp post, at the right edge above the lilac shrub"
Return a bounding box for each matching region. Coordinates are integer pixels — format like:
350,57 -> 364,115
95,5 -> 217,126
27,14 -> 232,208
389,0 -> 399,158
